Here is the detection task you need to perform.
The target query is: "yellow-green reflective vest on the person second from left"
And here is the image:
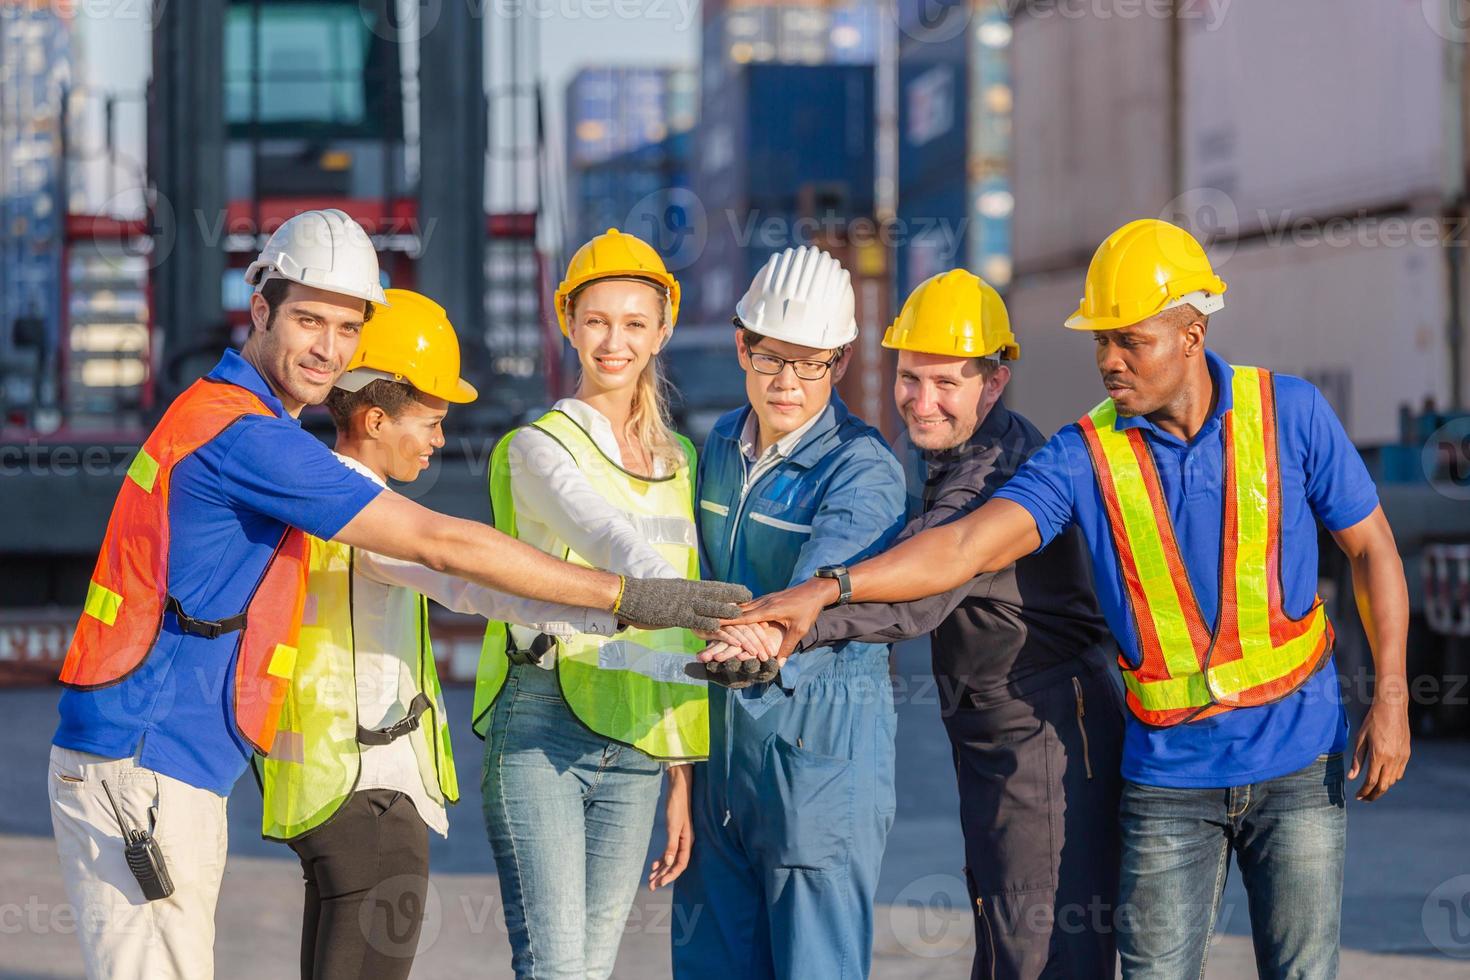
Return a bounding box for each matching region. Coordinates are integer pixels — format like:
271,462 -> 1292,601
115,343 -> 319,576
256,538 -> 459,840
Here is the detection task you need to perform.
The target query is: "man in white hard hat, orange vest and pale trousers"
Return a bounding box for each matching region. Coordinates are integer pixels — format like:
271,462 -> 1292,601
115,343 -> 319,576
49,210 -> 748,980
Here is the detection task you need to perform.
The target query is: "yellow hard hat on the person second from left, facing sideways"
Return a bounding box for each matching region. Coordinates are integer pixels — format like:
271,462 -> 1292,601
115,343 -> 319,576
337,289 -> 479,404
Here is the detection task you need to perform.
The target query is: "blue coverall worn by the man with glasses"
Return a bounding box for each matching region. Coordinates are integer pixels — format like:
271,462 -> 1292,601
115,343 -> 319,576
673,395 -> 904,980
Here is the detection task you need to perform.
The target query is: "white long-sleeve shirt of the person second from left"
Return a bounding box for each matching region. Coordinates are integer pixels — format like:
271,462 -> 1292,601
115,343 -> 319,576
337,454 -> 617,835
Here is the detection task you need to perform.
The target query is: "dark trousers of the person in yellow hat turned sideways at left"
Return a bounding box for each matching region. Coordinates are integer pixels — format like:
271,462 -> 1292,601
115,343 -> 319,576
283,789 -> 429,980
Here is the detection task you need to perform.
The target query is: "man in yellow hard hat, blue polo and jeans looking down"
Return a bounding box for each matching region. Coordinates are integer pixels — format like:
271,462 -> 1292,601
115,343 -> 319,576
748,219 -> 1410,980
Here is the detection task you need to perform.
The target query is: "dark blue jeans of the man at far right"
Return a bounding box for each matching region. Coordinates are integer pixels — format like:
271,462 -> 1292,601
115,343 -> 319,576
1116,754 -> 1348,980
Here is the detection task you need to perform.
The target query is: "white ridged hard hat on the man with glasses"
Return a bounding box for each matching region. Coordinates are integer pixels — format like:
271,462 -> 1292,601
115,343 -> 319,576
735,245 -> 857,350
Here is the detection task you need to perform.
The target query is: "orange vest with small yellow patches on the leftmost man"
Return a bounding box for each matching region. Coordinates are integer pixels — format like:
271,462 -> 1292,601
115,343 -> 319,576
60,379 -> 306,752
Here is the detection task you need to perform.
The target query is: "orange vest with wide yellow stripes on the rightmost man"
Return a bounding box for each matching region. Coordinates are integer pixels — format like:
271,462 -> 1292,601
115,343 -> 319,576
1079,367 -> 1333,726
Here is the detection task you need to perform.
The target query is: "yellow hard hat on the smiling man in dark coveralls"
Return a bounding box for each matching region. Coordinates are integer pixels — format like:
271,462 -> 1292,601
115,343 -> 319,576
883,269 -> 1020,360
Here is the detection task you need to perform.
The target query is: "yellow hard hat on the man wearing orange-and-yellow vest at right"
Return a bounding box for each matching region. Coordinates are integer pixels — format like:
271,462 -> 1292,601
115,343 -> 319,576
1067,217 -> 1226,331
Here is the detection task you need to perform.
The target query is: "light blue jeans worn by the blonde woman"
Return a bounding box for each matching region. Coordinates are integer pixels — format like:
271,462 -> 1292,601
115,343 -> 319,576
482,667 -> 663,980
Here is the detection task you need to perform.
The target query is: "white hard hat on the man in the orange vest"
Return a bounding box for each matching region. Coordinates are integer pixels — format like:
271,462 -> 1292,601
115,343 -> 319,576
245,207 -> 388,306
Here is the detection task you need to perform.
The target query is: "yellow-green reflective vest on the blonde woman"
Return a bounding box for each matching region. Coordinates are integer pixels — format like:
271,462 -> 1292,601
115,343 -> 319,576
475,410 -> 710,760
